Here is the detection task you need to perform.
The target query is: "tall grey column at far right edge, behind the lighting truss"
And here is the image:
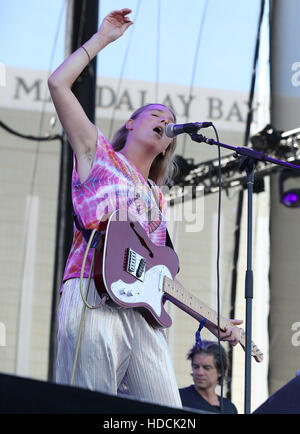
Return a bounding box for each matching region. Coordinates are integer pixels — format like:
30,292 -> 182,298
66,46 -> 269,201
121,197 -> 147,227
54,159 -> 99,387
269,0 -> 300,393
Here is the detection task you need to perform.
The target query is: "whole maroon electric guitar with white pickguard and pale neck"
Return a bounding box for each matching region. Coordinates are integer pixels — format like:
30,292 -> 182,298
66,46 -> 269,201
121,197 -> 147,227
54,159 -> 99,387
94,210 -> 263,362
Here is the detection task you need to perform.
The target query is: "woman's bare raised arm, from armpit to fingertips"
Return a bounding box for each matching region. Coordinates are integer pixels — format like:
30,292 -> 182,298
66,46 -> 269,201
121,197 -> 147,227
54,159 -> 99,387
48,9 -> 133,179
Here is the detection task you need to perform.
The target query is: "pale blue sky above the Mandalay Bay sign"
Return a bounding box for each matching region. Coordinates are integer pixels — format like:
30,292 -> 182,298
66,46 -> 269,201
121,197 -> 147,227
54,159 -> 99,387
0,0 -> 268,92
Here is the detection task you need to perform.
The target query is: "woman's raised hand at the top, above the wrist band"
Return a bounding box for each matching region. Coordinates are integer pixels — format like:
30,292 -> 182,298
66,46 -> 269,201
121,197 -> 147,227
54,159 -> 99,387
98,8 -> 133,43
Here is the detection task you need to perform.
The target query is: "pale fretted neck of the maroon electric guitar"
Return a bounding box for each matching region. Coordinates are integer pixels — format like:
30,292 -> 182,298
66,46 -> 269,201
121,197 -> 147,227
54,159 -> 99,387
163,276 -> 232,330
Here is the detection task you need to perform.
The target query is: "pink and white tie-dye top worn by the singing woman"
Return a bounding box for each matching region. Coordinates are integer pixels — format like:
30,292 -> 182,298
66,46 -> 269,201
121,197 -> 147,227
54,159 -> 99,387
63,131 -> 166,282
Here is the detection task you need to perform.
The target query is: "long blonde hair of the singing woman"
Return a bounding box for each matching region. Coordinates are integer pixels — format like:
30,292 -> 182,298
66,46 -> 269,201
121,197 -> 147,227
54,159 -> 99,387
111,104 -> 176,186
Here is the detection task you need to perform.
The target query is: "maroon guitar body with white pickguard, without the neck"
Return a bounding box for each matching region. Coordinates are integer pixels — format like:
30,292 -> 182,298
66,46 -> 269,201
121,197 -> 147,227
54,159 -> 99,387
94,210 -> 179,327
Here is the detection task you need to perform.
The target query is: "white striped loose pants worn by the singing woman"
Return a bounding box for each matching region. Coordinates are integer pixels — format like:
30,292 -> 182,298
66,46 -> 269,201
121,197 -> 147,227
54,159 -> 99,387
56,278 -> 181,407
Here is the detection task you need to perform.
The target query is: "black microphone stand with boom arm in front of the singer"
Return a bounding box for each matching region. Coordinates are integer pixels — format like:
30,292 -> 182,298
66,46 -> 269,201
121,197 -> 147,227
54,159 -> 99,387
190,133 -> 300,414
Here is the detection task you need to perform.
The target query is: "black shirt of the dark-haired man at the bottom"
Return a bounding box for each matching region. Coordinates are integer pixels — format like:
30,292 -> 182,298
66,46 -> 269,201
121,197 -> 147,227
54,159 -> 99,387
179,385 -> 237,414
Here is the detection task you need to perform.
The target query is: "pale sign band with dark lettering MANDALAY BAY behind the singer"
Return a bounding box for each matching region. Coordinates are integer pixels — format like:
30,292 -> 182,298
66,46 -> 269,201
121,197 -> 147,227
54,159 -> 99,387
0,68 -> 261,131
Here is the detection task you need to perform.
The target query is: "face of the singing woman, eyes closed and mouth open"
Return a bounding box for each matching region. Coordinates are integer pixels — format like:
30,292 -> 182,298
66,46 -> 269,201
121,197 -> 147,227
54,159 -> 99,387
127,104 -> 175,154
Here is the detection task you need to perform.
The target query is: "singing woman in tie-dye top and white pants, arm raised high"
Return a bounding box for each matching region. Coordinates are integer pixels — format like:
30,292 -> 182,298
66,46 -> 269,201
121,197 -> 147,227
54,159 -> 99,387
48,9 -> 241,407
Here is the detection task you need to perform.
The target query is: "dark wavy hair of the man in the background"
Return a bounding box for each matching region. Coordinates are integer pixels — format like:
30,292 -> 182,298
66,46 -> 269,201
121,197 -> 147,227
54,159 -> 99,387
187,341 -> 228,384
